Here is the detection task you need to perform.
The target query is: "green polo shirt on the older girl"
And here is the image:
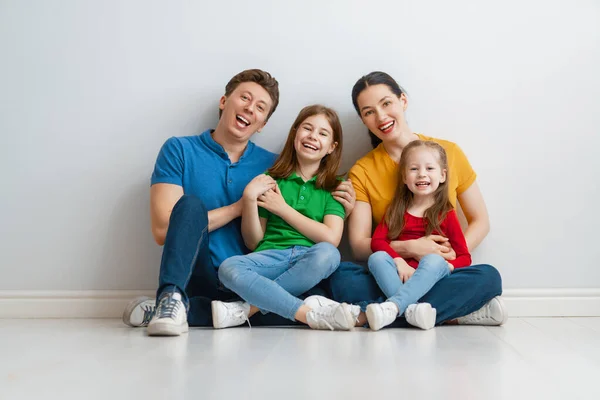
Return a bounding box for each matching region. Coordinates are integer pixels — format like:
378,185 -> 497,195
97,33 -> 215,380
254,172 -> 346,251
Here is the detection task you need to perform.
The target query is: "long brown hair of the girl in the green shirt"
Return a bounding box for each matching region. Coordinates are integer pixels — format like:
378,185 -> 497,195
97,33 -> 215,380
268,104 -> 342,192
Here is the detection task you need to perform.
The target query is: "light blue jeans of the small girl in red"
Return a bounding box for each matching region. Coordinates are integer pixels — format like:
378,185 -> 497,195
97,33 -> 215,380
368,251 -> 450,316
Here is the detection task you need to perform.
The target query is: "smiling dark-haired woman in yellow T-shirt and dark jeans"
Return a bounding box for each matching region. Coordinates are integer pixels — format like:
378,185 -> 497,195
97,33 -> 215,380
330,72 -> 507,326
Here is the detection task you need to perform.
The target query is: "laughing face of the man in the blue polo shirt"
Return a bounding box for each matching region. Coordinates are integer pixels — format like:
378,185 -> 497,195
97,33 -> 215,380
219,82 -> 273,141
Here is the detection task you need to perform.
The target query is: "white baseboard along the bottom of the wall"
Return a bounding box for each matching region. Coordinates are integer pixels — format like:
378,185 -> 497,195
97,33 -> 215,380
0,288 -> 600,318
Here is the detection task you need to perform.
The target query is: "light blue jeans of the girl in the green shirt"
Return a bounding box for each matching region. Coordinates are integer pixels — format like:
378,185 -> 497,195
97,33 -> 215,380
219,242 -> 340,321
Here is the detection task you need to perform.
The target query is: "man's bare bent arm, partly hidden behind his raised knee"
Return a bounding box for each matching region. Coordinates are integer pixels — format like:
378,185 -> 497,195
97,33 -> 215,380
150,183 -> 242,246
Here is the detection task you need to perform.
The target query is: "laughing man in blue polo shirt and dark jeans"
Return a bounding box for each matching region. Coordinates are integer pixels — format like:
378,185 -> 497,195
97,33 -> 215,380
123,69 -> 354,336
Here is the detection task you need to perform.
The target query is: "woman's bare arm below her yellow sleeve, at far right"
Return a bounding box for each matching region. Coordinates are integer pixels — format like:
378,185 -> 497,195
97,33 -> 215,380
458,182 -> 490,251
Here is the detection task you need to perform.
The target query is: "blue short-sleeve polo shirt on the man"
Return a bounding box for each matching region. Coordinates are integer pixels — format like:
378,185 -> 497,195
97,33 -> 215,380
151,130 -> 277,268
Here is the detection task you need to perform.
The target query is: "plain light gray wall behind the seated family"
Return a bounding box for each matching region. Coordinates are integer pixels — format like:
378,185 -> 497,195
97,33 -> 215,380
0,0 -> 600,290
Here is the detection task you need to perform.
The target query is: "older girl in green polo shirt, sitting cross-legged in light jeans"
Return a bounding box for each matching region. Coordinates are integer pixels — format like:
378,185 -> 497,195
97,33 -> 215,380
212,105 -> 360,330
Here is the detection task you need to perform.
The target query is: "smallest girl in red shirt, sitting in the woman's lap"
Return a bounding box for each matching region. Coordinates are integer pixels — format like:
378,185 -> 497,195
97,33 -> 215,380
367,140 -> 471,330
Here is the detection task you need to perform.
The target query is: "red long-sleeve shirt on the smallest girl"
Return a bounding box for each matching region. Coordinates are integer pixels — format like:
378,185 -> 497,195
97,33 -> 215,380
371,210 -> 471,269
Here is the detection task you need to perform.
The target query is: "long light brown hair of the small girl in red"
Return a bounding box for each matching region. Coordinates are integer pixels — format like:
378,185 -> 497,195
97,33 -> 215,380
385,140 -> 453,240
